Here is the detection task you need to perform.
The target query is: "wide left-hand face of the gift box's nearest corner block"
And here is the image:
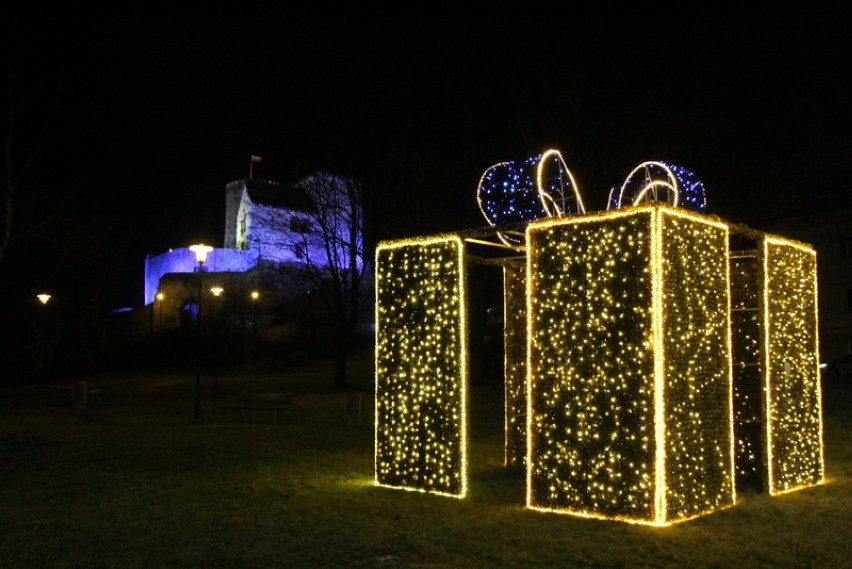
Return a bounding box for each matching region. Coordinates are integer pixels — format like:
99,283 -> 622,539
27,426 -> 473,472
527,209 -> 655,517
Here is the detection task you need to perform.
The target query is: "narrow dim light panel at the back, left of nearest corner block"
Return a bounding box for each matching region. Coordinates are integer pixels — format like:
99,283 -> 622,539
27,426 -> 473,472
503,265 -> 527,466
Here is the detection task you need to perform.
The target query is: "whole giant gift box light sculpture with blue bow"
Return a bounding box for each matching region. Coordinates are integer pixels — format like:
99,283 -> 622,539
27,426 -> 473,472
375,150 -> 824,525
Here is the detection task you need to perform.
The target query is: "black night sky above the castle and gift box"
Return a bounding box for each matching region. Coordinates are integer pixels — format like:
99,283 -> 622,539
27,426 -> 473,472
0,2 -> 852,304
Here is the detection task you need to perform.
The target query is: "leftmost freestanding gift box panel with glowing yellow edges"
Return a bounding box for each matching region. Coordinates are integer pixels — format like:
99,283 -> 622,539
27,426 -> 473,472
375,237 -> 468,497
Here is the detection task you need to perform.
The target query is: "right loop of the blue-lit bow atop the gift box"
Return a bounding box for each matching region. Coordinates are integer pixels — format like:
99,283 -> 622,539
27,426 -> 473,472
607,162 -> 707,213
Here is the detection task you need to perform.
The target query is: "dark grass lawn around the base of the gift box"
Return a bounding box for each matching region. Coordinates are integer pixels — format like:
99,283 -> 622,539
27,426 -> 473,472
0,354 -> 852,568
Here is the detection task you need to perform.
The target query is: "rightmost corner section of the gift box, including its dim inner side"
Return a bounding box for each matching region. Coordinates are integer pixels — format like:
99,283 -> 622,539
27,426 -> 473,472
730,232 -> 825,494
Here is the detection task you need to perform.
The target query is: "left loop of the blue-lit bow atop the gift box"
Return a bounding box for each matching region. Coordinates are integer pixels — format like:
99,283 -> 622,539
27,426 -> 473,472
477,150 -> 585,245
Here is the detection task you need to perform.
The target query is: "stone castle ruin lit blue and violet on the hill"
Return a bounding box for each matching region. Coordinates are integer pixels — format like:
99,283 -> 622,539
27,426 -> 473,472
144,172 -> 364,328
